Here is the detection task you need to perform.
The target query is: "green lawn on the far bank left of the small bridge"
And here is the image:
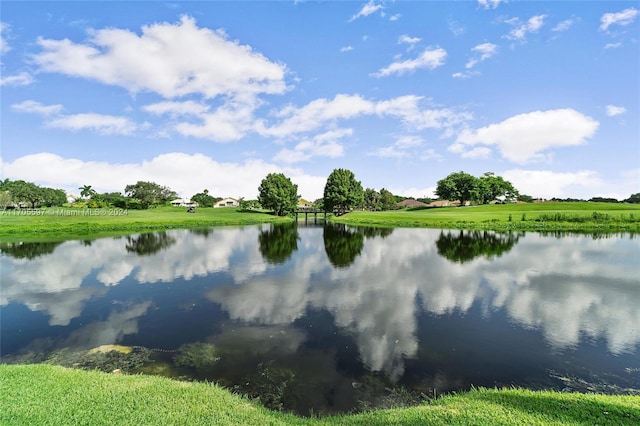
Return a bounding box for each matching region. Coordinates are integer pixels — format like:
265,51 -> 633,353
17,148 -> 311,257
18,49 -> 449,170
0,207 -> 291,242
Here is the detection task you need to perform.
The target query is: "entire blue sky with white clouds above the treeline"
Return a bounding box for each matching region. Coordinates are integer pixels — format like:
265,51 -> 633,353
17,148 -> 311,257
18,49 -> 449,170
0,0 -> 640,200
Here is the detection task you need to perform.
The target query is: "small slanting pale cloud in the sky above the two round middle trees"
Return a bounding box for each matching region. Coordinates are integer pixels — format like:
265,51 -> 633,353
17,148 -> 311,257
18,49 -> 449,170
273,129 -> 353,164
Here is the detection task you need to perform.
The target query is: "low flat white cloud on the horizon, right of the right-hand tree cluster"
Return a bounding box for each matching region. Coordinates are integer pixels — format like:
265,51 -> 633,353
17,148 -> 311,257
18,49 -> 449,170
502,169 -> 604,199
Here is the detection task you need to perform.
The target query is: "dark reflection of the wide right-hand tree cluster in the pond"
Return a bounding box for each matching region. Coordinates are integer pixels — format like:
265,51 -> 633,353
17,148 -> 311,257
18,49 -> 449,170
436,230 -> 520,263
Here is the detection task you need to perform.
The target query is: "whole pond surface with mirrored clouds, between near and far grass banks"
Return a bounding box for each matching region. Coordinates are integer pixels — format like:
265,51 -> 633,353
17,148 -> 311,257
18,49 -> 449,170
0,225 -> 640,415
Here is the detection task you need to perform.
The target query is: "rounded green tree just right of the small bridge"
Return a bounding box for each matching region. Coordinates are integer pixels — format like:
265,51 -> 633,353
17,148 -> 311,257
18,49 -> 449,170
324,169 -> 364,214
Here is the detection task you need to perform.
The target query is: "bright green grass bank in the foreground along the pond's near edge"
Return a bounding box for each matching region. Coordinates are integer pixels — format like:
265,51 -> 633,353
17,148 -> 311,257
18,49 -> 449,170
0,364 -> 640,426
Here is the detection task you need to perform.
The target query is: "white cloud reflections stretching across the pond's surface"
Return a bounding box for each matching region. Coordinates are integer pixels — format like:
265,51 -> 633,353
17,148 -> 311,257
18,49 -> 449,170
0,227 -> 640,377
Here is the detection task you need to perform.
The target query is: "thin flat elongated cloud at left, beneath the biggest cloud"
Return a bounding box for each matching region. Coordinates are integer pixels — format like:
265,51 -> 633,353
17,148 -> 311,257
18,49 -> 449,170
46,113 -> 138,135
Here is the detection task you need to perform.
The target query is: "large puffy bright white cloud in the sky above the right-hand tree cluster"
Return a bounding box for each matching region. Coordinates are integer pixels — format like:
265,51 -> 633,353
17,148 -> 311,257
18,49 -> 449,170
450,108 -> 599,164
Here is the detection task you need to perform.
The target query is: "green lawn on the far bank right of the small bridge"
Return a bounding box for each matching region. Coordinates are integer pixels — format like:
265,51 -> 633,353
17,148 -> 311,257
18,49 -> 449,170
332,202 -> 640,232
